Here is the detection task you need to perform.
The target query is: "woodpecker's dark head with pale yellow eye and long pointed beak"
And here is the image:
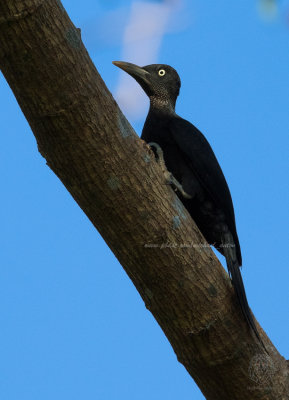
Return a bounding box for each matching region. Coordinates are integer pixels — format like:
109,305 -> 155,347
113,61 -> 181,107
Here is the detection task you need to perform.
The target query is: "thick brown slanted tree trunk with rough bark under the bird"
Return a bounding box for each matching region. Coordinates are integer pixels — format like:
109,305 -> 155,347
0,0 -> 289,400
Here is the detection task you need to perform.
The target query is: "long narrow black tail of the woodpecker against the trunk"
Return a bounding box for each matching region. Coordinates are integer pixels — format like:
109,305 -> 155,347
223,232 -> 267,352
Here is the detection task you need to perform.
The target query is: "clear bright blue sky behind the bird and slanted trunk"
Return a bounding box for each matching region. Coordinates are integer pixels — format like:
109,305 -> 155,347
0,0 -> 289,400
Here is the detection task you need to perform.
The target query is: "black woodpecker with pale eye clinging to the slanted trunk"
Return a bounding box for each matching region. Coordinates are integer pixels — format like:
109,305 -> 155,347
113,61 -> 266,350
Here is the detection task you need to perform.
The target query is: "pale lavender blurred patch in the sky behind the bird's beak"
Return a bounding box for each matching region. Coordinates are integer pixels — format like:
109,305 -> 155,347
115,0 -> 182,119
